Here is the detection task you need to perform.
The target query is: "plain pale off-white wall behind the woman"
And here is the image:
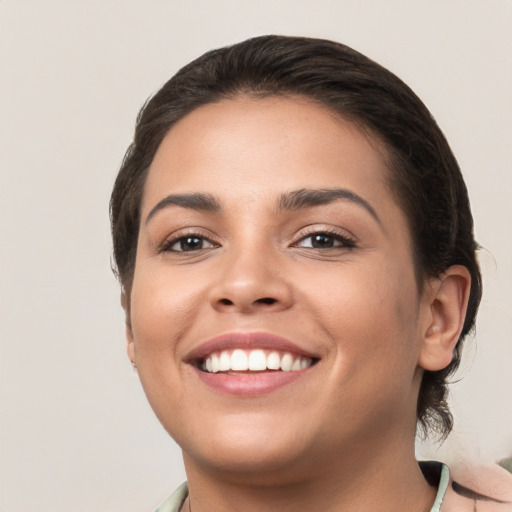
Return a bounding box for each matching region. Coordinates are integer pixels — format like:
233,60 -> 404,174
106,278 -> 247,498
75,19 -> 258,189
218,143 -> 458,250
0,0 -> 512,512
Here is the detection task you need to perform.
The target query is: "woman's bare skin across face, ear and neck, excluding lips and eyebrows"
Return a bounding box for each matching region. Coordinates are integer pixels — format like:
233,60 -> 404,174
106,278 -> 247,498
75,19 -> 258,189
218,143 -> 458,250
124,97 -> 470,512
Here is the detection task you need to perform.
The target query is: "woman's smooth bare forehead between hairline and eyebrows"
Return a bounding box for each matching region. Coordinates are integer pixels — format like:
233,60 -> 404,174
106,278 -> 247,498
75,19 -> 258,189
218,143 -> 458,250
143,96 -> 394,210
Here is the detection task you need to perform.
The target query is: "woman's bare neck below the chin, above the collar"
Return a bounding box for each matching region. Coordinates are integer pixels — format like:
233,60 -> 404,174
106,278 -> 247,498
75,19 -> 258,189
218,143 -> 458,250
180,432 -> 436,512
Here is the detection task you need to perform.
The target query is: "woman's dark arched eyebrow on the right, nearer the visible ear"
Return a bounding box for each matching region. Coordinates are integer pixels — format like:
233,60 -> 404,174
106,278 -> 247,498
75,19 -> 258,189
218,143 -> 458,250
277,188 -> 381,224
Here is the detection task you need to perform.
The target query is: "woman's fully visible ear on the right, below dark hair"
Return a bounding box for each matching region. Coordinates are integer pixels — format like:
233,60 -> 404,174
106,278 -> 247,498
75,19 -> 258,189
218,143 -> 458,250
418,265 -> 471,371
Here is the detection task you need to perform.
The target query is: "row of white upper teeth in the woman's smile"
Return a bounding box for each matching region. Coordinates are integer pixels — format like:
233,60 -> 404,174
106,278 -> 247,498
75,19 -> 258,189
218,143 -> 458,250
200,348 -> 313,373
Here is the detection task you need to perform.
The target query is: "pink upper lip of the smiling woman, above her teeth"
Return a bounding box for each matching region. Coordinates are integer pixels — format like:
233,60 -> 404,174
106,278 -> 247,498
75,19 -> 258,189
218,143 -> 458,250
185,332 -> 318,362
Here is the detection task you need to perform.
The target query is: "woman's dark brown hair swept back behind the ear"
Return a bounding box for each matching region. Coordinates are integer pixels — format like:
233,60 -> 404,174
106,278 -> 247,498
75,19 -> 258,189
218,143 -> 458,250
110,36 -> 482,437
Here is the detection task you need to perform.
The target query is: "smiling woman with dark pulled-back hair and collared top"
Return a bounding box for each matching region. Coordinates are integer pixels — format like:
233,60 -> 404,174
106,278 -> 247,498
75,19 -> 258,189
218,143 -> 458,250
111,36 -> 510,512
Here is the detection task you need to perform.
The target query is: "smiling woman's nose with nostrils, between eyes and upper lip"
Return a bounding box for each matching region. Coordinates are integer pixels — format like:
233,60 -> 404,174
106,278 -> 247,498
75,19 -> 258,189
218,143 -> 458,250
210,246 -> 293,314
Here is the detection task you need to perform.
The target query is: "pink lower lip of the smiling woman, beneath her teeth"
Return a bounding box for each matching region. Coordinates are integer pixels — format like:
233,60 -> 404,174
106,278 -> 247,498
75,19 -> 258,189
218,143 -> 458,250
194,367 -> 311,396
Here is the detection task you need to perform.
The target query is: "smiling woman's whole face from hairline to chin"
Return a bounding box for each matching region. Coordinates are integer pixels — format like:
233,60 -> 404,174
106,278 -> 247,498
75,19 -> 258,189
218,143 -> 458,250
128,97 -> 429,484
